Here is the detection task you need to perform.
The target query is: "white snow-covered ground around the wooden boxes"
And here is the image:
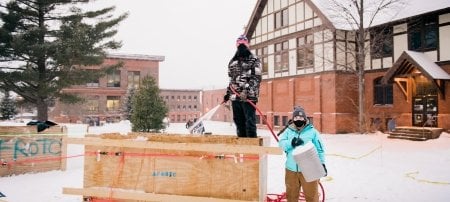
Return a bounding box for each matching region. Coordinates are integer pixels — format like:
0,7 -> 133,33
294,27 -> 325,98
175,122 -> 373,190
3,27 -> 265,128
0,121 -> 450,202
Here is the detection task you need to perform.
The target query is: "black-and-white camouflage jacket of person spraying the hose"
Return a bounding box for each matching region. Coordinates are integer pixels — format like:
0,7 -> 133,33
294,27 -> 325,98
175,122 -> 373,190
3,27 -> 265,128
227,54 -> 262,103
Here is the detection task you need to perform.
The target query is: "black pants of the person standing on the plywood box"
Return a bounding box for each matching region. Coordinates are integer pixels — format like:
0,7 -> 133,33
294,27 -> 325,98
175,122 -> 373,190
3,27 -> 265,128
231,101 -> 256,137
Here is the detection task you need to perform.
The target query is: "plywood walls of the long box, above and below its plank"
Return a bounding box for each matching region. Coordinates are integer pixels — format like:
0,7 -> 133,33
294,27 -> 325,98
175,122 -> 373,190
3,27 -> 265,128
75,133 -> 272,201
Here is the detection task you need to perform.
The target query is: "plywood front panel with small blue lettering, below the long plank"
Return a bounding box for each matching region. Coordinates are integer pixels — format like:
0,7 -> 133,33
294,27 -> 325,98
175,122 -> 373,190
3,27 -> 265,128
84,146 -> 265,200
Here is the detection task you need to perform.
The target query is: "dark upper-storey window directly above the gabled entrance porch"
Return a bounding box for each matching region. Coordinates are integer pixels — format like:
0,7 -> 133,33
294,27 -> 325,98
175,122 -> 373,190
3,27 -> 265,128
408,17 -> 438,51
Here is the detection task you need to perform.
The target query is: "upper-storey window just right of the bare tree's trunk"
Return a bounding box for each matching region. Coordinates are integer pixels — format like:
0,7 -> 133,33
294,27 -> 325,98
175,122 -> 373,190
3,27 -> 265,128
370,27 -> 394,58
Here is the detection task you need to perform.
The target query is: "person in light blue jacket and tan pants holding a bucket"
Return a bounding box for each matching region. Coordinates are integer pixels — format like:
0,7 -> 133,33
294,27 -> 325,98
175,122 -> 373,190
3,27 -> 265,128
278,106 -> 327,202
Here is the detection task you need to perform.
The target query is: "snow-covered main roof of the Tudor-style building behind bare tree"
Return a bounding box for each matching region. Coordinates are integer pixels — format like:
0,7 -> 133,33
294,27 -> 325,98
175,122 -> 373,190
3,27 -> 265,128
311,0 -> 450,30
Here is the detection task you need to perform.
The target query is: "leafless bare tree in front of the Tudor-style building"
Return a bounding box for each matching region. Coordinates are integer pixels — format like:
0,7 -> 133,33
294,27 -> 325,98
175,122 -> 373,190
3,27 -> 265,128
321,0 -> 405,133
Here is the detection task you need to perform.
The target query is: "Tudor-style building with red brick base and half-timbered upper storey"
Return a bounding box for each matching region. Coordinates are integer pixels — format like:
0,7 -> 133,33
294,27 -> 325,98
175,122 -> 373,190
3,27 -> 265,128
236,0 -> 450,133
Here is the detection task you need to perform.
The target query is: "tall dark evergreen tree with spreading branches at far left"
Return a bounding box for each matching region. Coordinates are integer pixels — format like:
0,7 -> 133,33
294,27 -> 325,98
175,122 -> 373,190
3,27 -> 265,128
0,0 -> 127,121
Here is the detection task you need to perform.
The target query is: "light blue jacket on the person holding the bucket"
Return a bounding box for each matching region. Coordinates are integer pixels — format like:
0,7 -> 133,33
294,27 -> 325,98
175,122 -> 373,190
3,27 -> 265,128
278,124 -> 325,172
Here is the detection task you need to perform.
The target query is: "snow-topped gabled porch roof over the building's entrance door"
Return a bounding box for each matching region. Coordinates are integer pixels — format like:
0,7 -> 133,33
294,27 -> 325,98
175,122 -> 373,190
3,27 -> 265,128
382,51 -> 450,83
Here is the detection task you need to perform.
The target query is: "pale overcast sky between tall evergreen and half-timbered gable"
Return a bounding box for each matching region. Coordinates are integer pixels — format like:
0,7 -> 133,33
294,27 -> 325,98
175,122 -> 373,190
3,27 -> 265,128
92,0 -> 257,89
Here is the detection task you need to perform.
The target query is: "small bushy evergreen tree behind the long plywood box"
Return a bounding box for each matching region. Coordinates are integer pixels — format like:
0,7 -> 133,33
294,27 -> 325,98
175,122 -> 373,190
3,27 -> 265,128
131,76 -> 169,132
